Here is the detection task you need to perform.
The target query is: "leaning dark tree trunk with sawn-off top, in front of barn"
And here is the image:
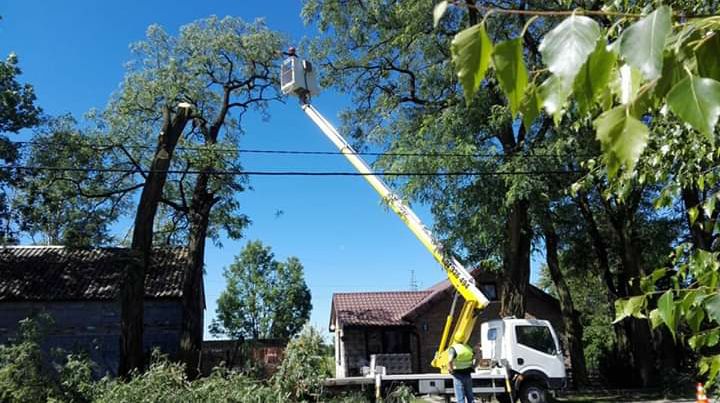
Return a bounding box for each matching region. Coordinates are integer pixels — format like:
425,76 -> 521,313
119,107 -> 190,377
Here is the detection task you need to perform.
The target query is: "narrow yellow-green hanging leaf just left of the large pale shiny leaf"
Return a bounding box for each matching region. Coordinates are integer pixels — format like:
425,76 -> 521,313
492,38 -> 528,117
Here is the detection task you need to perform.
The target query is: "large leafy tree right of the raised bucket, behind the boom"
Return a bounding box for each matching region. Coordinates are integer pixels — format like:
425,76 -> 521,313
303,0 -> 551,316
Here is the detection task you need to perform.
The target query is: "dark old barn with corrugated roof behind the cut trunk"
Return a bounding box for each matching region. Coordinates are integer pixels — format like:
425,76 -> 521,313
0,246 -> 205,375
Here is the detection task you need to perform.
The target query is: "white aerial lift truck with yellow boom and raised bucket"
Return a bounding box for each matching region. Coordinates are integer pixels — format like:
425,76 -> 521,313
280,48 -> 566,403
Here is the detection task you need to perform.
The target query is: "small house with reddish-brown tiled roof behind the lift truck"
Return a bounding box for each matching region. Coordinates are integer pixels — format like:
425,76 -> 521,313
330,270 -> 562,378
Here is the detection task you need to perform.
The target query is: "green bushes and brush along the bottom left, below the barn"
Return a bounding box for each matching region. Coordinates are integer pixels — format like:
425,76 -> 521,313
0,319 -> 340,403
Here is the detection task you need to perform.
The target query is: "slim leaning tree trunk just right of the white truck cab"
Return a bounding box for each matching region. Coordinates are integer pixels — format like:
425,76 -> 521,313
543,220 -> 587,389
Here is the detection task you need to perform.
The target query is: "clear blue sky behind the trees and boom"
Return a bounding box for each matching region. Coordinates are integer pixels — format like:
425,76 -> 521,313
0,0 -> 540,337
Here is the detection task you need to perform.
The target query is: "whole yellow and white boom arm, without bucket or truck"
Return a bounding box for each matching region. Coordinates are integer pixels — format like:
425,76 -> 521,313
301,102 -> 489,372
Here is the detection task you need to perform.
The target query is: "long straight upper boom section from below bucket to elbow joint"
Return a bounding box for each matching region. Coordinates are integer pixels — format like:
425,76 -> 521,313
302,103 -> 489,308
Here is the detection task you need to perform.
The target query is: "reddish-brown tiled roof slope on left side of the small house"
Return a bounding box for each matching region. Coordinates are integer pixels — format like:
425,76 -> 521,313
330,291 -> 430,326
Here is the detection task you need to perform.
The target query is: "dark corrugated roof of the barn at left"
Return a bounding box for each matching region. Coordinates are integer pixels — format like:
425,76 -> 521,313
0,246 -> 188,301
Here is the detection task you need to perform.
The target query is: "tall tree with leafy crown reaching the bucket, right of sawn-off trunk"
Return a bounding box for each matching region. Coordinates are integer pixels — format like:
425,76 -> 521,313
157,18 -> 283,377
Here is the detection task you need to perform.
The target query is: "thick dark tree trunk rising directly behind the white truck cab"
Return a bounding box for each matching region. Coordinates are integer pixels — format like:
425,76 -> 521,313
500,200 -> 532,318
